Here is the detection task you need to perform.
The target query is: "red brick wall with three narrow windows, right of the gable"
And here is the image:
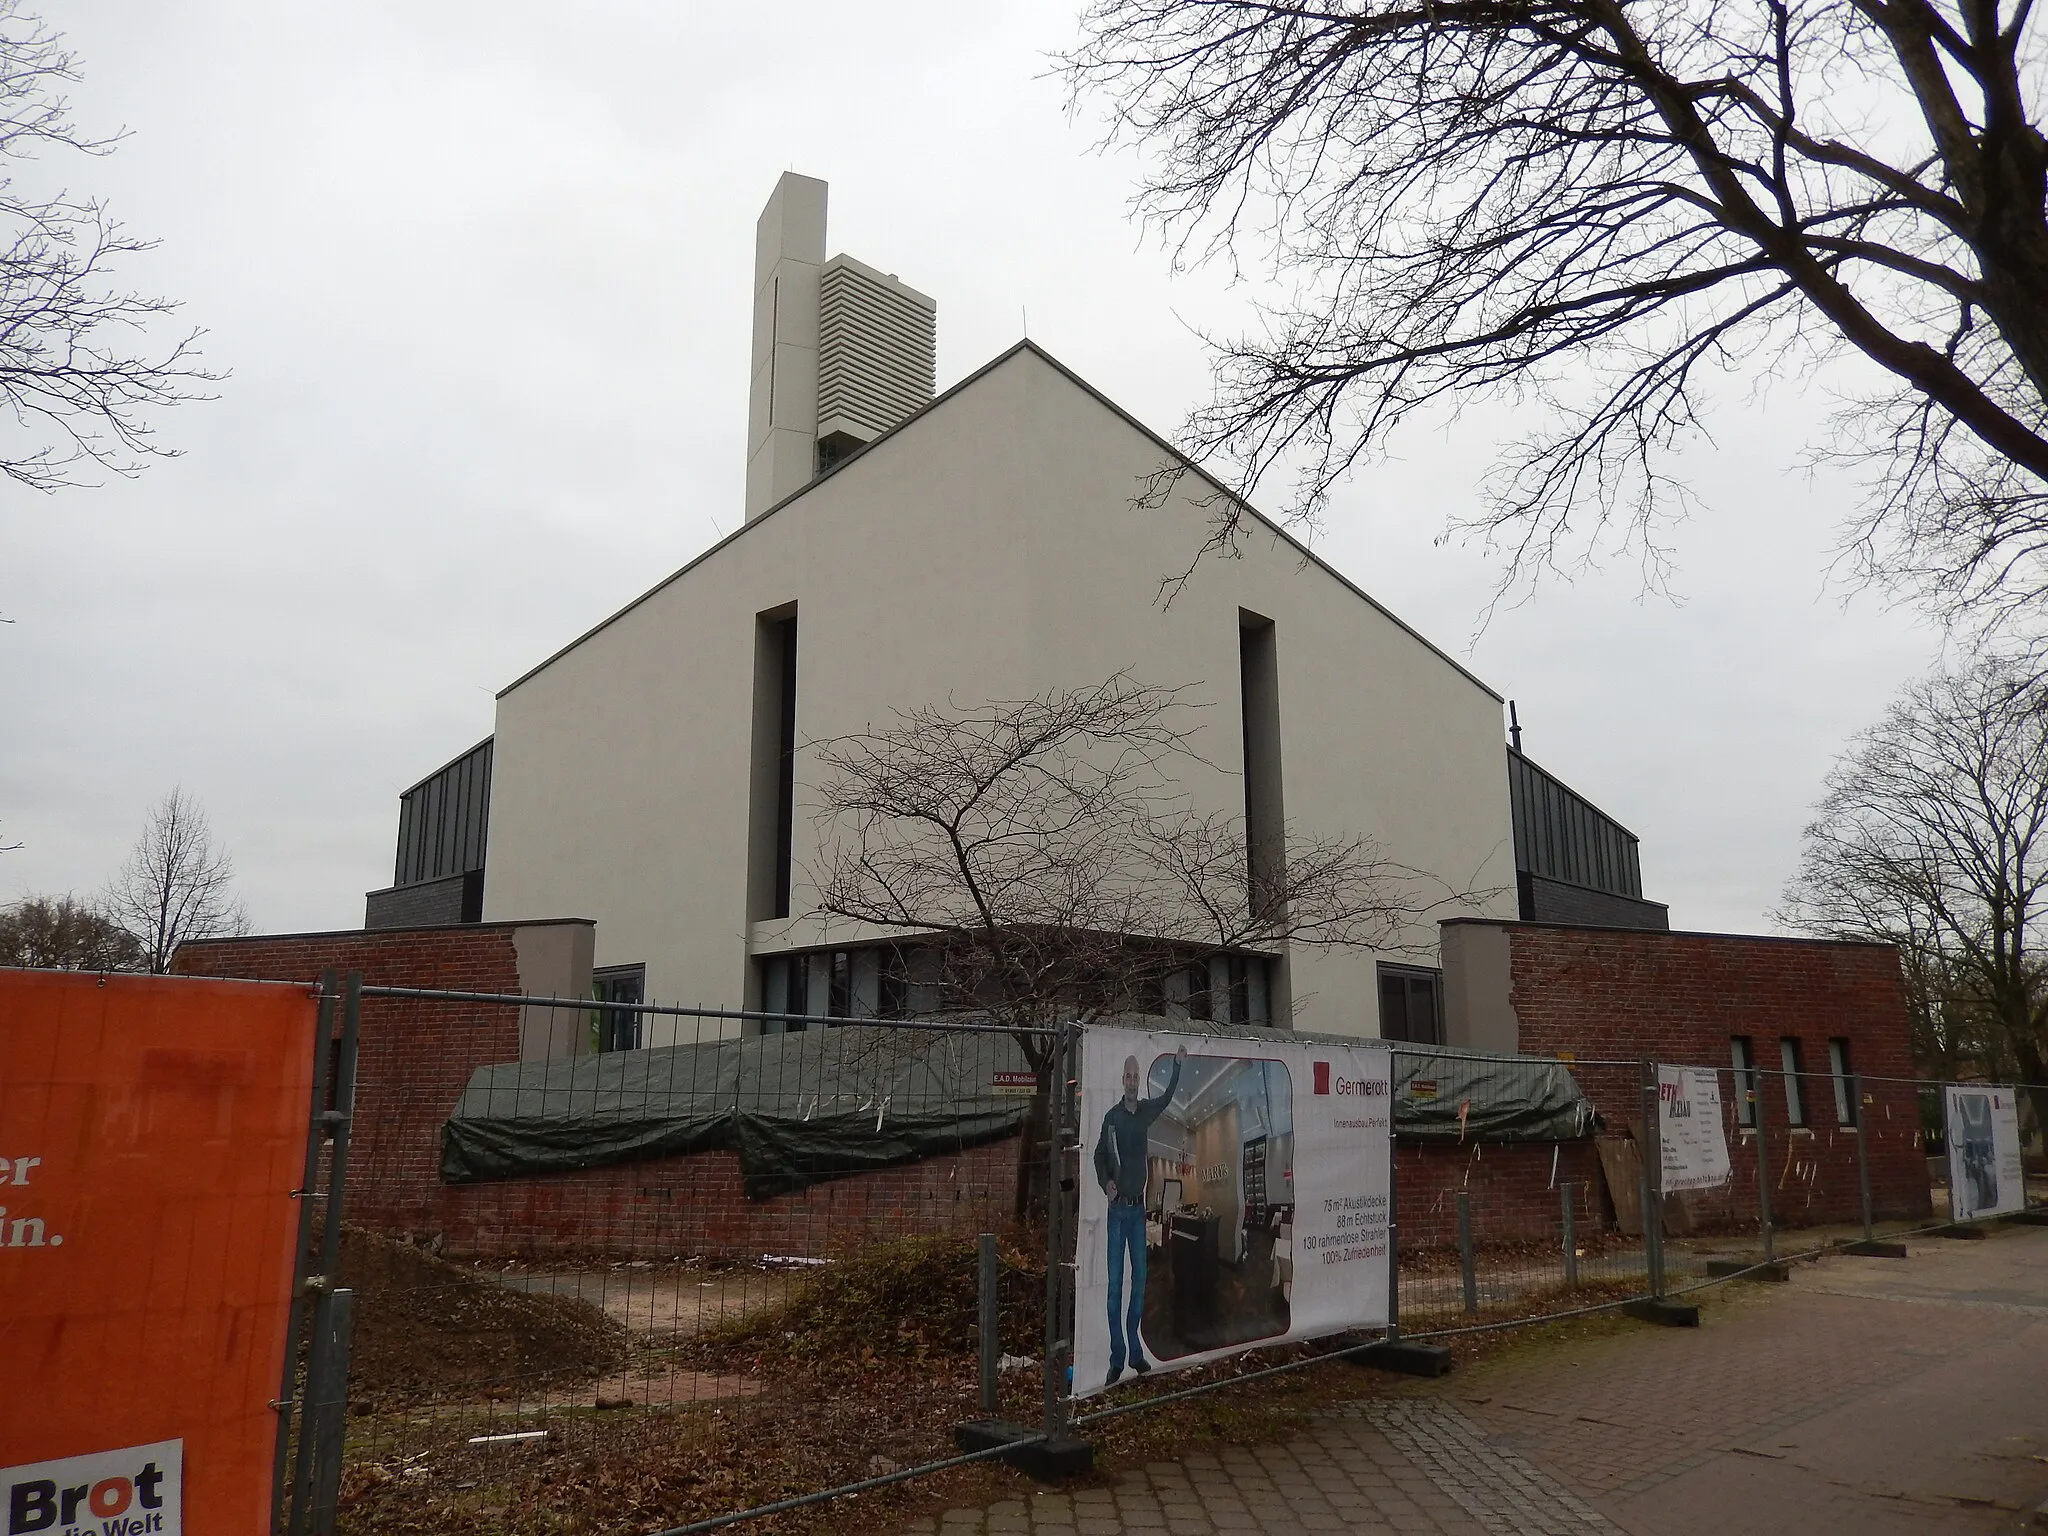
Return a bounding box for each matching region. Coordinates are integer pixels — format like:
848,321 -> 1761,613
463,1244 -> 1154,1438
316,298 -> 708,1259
1505,924 -> 1929,1225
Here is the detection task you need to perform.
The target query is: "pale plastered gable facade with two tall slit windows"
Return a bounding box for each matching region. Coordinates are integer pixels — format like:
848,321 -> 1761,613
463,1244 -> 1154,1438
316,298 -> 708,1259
485,344 -> 1516,1044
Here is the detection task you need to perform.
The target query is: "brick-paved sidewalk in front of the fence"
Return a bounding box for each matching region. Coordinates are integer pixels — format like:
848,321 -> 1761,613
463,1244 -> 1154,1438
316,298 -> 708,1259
911,1229 -> 2048,1536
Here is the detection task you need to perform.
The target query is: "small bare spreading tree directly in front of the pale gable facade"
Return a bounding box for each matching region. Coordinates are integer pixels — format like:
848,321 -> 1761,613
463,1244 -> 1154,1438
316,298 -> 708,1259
813,676 -> 1489,1219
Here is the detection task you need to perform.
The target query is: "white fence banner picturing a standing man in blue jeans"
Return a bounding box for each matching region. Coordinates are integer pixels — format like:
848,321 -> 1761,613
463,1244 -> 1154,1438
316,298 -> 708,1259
1073,1028 -> 1393,1397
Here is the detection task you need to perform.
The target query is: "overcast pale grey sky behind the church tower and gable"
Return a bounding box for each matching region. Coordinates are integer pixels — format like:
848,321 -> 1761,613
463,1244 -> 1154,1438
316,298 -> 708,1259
0,0 -> 1937,946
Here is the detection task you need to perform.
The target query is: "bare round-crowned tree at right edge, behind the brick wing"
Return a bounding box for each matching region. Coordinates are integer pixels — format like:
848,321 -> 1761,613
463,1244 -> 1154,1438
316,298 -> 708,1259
1778,659 -> 2048,1124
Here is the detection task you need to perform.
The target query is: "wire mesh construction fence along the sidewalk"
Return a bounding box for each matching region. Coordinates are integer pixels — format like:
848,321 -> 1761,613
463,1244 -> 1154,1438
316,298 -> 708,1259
276,977 -> 2040,1536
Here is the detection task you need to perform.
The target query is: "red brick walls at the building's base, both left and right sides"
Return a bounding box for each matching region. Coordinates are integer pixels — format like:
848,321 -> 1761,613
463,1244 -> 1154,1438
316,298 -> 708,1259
174,924 -> 1927,1255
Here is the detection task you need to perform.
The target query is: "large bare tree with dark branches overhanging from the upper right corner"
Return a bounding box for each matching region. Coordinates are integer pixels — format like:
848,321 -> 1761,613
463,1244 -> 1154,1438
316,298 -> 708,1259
1067,0 -> 2048,618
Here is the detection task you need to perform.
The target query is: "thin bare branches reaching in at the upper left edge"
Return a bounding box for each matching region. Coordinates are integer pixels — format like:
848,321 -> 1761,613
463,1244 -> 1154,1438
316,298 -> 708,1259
0,0 -> 217,492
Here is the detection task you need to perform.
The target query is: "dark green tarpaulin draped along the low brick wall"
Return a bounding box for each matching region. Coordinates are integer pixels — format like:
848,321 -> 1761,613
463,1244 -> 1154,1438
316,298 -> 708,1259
440,1020 -> 1595,1200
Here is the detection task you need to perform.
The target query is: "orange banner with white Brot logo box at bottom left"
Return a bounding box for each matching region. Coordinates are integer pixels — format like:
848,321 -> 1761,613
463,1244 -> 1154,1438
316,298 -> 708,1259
0,971 -> 315,1536
